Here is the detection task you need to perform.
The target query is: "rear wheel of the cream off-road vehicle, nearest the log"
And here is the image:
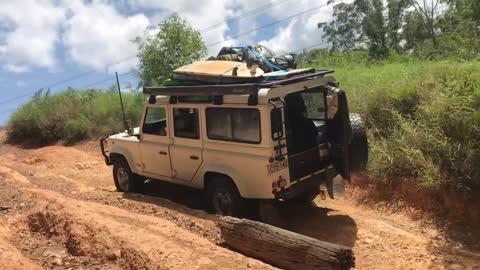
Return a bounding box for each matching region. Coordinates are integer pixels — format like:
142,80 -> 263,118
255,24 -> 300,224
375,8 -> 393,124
205,176 -> 244,216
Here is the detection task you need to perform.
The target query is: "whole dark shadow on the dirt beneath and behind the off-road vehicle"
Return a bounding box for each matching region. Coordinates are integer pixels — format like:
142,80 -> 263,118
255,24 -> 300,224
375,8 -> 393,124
124,180 -> 357,247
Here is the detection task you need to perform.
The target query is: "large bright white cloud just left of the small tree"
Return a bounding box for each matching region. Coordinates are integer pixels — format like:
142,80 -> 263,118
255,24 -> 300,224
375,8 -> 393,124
63,1 -> 149,72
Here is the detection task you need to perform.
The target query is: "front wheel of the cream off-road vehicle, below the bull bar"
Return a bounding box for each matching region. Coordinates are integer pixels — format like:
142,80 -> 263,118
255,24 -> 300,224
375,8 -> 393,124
113,158 -> 144,192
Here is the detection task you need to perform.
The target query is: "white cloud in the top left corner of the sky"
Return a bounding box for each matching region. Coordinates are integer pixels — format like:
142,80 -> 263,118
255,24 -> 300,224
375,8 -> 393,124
0,0 -> 64,72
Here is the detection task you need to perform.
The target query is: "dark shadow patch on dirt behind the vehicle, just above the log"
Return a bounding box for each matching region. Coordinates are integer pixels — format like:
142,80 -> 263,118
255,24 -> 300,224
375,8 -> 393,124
256,202 -> 358,247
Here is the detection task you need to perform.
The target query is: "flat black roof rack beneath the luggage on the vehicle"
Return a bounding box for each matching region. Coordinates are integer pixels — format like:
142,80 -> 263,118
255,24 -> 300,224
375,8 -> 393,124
143,69 -> 334,96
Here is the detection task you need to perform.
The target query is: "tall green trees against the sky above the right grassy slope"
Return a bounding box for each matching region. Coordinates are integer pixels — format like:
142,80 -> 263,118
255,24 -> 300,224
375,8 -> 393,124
323,0 -> 480,60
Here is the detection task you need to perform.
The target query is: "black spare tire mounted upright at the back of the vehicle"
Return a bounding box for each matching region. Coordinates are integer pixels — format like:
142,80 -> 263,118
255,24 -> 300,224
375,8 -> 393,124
350,113 -> 368,173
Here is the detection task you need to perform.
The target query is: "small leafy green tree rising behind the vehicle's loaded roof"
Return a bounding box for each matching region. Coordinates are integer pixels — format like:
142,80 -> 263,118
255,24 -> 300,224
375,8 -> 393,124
135,14 -> 207,85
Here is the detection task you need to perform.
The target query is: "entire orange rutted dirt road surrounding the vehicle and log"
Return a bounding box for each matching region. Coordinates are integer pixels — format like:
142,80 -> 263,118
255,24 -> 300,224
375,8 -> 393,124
0,130 -> 480,269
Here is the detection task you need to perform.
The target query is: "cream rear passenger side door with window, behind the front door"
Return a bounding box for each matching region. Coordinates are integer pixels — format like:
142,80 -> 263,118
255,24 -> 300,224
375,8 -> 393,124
169,104 -> 203,181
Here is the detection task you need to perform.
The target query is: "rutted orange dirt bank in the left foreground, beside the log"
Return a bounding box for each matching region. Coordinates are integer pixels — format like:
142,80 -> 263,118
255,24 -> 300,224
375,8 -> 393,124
0,167 -> 271,269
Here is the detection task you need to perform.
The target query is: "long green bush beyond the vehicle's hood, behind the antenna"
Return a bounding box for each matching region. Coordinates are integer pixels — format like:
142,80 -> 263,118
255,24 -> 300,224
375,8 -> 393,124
7,89 -> 144,145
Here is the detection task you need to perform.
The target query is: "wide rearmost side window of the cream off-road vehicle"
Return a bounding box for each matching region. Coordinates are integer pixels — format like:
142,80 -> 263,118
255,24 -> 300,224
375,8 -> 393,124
206,108 -> 261,144
